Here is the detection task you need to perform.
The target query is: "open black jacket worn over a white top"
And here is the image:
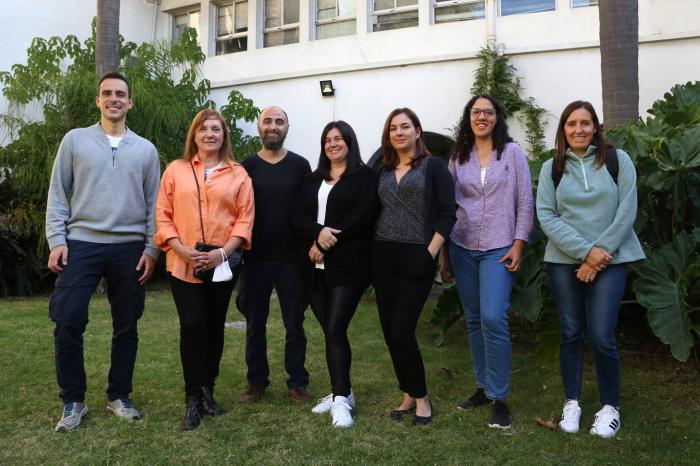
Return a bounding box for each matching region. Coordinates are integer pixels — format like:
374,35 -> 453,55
292,166 -> 379,289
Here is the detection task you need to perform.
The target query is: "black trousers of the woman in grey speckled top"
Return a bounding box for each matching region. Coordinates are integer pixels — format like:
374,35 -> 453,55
372,241 -> 437,398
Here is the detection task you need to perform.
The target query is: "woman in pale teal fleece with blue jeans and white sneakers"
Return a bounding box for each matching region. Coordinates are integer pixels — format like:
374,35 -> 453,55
537,101 -> 644,438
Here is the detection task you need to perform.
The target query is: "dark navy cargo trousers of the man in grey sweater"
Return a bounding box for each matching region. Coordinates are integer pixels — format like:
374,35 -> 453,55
49,240 -> 145,403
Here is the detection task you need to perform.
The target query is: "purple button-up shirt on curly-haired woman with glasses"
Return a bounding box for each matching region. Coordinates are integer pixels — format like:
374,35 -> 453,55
448,142 -> 534,251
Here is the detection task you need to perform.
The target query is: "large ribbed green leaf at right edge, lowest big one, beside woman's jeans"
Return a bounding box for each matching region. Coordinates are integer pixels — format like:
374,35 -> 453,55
633,233 -> 698,361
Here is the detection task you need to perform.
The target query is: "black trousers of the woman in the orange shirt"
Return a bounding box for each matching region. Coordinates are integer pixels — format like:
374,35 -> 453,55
170,275 -> 236,396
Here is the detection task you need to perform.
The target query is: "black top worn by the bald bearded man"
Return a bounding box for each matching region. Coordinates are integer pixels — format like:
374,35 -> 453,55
242,151 -> 311,262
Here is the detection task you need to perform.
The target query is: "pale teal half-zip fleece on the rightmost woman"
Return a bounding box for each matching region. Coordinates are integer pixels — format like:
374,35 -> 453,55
536,146 -> 644,264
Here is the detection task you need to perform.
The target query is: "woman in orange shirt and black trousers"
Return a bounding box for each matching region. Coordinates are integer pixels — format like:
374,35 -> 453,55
155,109 -> 254,430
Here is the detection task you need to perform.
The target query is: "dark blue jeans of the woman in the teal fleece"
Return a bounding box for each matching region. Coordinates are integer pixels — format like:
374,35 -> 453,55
547,263 -> 627,407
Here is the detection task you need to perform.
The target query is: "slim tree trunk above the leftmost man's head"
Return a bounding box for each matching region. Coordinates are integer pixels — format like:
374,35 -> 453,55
95,0 -> 119,76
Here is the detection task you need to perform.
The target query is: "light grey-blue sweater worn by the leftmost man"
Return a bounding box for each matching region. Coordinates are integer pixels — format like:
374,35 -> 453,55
46,123 -> 160,258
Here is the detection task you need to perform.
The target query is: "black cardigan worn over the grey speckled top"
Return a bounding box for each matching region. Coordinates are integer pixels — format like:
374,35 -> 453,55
380,156 -> 457,245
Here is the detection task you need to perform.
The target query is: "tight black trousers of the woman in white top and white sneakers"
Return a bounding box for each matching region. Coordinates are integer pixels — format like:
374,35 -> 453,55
308,269 -> 365,397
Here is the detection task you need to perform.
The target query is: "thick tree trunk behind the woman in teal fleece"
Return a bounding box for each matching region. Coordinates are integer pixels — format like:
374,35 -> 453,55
598,0 -> 639,128
